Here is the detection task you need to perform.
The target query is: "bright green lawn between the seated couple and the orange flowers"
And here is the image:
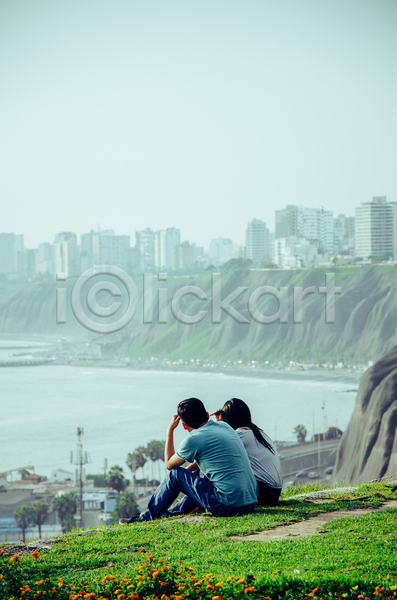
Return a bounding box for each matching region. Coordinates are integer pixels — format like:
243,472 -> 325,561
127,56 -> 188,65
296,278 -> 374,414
3,483 -> 397,586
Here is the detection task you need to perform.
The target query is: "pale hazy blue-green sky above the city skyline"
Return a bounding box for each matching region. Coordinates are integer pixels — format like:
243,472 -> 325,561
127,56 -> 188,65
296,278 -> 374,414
0,0 -> 397,247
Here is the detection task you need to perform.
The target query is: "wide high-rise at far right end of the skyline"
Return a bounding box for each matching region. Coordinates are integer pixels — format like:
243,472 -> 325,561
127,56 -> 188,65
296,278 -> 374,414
354,196 -> 397,258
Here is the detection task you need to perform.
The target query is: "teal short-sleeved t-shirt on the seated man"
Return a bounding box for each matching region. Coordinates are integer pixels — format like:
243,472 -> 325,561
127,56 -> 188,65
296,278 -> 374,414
177,421 -> 257,506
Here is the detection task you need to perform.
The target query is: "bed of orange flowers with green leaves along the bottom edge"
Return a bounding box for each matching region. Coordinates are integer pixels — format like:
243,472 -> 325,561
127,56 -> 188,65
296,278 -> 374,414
0,550 -> 397,600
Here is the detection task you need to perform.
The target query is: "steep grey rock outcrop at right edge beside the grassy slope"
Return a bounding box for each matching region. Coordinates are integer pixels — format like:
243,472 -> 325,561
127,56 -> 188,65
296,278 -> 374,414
333,347 -> 397,483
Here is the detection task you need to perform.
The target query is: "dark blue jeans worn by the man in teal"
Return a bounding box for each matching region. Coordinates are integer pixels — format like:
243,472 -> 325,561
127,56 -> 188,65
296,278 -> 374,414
140,467 -> 255,521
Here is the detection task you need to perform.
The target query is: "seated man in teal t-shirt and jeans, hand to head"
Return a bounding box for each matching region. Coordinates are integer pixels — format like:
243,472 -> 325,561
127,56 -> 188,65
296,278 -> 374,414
119,398 -> 257,524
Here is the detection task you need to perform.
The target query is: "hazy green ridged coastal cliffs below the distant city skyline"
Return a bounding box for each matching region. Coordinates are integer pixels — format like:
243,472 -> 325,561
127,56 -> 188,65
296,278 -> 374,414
0,266 -> 397,363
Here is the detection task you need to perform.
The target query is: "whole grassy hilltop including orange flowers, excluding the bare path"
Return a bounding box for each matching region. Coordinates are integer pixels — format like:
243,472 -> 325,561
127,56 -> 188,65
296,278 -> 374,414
0,482 -> 397,600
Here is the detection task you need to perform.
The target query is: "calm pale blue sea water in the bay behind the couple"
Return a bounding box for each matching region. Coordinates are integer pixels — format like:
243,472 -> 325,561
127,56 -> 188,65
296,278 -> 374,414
0,346 -> 357,475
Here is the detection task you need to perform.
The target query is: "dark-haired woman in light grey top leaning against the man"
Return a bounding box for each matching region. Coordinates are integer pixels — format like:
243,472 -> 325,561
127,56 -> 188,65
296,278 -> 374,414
213,398 -> 283,506
